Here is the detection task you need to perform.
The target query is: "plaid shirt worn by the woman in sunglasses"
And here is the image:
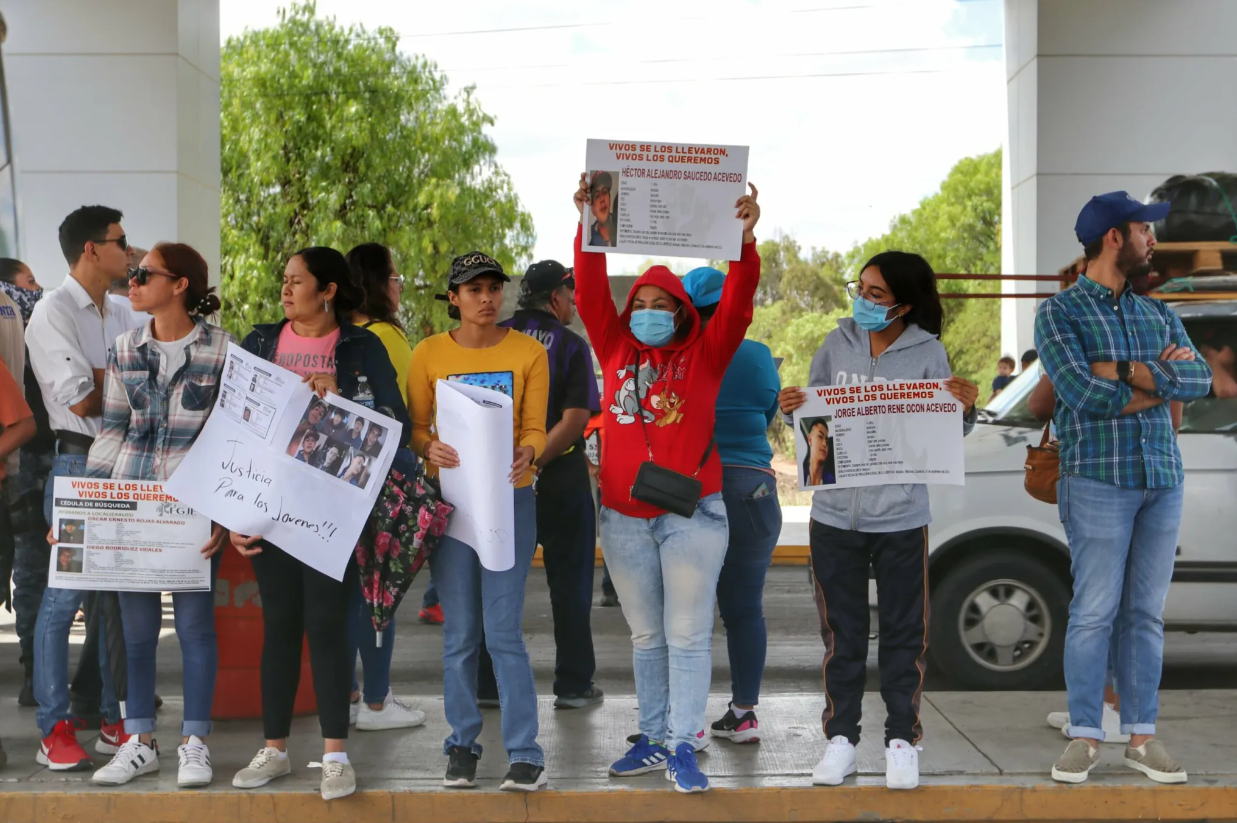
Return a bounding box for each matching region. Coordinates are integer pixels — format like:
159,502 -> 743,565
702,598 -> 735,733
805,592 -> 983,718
85,319 -> 234,480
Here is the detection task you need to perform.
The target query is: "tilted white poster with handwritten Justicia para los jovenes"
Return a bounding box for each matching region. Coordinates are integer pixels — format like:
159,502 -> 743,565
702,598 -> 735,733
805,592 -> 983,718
167,344 -> 403,580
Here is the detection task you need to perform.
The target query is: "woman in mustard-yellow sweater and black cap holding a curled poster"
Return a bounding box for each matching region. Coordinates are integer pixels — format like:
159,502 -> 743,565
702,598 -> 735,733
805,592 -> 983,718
408,251 -> 549,792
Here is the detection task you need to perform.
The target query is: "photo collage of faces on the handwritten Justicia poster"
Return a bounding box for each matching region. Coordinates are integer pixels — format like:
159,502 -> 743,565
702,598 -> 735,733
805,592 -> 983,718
287,397 -> 387,489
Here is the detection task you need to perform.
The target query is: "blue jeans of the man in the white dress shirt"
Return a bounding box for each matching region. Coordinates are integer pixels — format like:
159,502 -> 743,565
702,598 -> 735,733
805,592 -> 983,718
35,454 -> 120,736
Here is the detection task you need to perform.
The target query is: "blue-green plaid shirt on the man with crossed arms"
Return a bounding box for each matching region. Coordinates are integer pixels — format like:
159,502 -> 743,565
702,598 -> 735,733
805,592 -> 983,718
1035,276 -> 1211,489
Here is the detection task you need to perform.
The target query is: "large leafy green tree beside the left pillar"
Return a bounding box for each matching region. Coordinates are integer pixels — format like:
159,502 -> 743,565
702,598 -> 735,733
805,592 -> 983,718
220,1 -> 533,337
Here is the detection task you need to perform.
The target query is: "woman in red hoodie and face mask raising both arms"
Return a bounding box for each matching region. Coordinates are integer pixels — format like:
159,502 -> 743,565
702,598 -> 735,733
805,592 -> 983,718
575,175 -> 761,792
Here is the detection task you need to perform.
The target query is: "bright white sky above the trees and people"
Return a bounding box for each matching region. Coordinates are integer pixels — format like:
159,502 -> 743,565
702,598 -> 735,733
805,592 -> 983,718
219,0 -> 1006,269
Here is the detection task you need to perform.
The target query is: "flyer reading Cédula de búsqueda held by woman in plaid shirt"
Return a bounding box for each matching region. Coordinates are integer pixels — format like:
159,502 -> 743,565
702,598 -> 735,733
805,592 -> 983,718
47,478 -> 210,592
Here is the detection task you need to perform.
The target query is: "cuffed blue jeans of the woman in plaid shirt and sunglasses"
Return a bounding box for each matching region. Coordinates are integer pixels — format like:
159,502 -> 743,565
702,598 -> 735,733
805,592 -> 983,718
120,546 -> 222,738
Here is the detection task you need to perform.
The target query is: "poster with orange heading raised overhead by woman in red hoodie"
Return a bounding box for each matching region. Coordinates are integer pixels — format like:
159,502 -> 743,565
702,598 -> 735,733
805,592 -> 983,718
581,140 -> 747,260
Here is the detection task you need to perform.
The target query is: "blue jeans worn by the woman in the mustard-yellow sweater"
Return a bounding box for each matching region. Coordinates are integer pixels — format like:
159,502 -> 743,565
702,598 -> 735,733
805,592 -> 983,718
429,488 -> 546,766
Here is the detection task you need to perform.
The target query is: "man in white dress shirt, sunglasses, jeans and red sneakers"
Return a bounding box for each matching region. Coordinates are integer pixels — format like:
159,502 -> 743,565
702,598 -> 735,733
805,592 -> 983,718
26,205 -> 141,771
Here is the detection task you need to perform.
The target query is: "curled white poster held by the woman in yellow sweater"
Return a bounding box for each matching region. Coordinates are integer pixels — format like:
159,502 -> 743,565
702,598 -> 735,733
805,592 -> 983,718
434,375 -> 516,572
